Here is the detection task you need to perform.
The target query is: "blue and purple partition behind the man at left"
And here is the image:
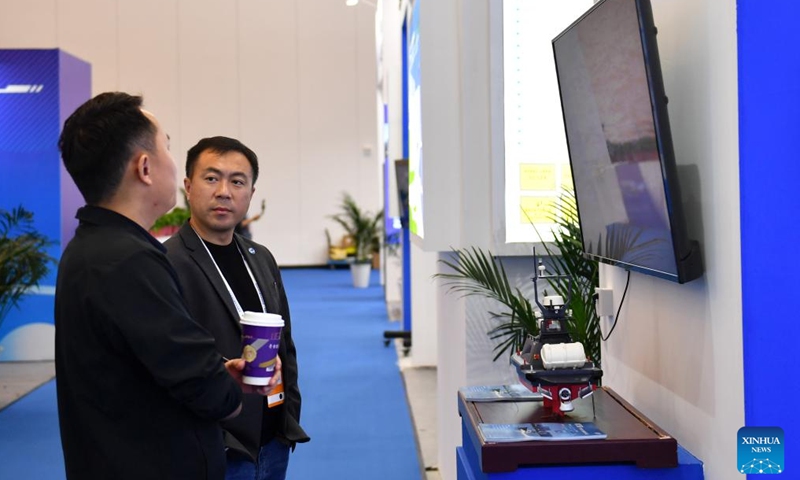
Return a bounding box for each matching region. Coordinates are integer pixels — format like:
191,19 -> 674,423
0,49 -> 91,361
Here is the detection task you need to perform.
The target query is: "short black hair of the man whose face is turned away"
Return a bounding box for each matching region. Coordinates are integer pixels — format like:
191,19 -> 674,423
58,92 -> 156,205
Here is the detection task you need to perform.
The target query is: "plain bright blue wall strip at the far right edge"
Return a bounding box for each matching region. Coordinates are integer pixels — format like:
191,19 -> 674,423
736,0 -> 800,478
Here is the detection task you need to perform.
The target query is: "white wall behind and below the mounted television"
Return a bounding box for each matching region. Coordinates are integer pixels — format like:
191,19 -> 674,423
601,0 -> 744,480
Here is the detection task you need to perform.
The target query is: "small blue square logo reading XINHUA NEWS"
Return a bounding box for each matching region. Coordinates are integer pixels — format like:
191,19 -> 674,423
736,427 -> 784,475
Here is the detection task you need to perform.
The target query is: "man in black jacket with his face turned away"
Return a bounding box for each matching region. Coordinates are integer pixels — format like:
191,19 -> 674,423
55,92 -> 280,480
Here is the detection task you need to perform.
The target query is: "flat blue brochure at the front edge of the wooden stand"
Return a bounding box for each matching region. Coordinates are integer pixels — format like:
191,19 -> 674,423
478,422 -> 606,443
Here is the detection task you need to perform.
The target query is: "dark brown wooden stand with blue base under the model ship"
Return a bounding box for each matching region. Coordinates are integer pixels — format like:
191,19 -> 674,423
458,387 -> 703,480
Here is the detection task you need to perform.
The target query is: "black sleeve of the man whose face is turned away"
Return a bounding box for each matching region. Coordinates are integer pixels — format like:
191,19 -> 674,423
99,251 -> 242,420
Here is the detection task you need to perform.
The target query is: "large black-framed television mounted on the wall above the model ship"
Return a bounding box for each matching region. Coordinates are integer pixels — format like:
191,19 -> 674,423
552,0 -> 703,283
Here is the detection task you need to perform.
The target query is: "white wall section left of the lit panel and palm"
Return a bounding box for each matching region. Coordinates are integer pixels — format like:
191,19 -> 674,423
411,0 -> 492,480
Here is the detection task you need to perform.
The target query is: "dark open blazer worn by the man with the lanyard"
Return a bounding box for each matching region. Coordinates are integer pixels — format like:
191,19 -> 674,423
164,222 -> 309,458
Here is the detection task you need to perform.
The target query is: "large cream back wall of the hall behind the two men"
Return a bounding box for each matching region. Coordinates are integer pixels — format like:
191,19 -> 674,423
0,0 -> 382,265
